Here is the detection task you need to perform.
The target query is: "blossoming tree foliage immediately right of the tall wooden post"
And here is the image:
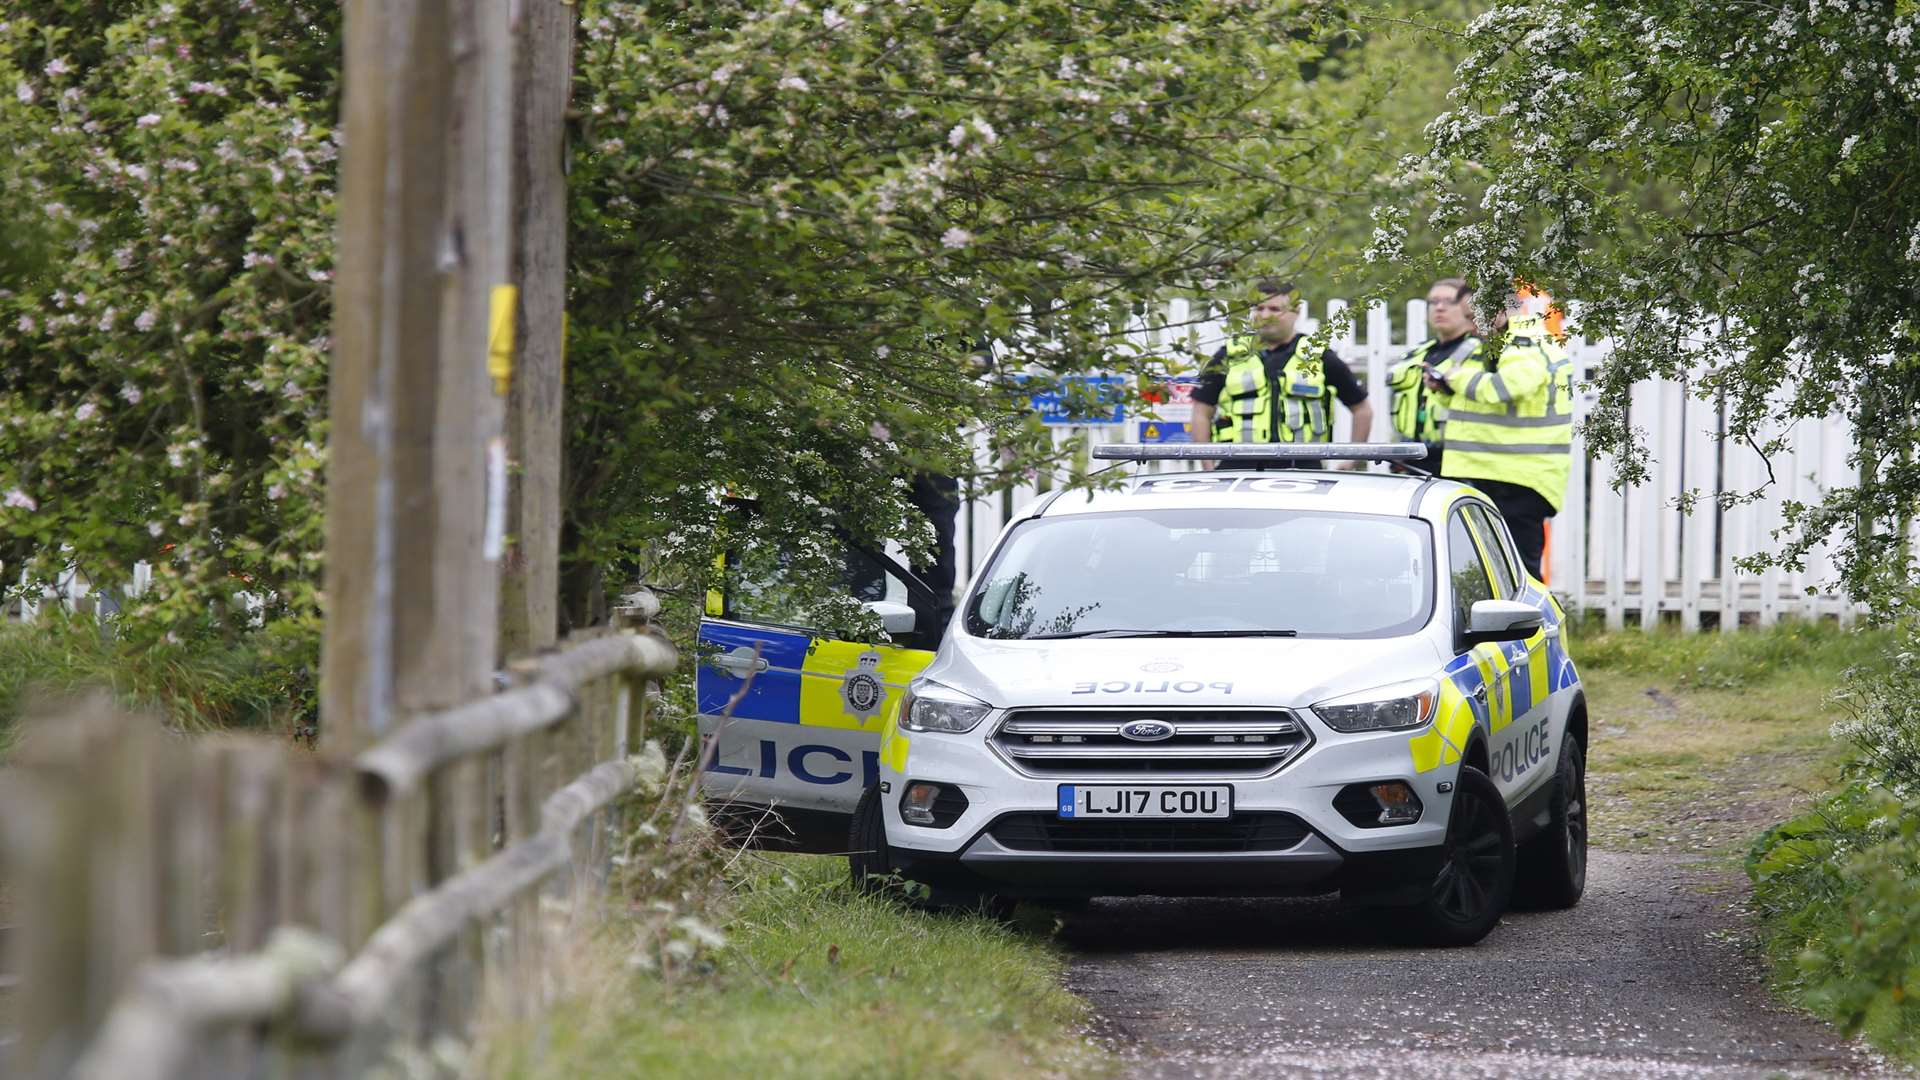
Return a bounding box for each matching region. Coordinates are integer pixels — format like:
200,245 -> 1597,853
568,0 -> 1388,614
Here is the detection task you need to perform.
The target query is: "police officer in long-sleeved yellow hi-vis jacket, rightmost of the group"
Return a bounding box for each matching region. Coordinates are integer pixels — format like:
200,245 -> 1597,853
1427,284 -> 1572,578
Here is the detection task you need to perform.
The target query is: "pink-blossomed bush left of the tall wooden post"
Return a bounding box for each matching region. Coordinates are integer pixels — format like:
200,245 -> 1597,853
0,0 -> 338,640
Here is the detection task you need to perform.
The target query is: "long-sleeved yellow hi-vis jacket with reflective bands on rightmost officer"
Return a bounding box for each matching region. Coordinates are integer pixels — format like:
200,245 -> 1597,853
1440,319 -> 1572,511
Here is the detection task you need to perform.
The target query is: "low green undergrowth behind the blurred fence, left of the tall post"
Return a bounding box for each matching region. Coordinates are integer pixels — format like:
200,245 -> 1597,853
0,607 -> 317,746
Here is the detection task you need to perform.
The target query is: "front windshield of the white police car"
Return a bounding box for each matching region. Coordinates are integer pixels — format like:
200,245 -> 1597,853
966,507 -> 1432,640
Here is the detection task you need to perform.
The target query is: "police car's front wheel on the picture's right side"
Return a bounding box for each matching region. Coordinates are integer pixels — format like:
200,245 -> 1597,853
1394,765 -> 1515,947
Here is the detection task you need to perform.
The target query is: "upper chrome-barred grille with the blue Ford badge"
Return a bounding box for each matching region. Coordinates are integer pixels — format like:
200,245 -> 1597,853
993,709 -> 1311,778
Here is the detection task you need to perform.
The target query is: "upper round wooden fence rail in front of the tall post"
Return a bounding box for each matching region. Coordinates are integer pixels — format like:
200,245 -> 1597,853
353,634 -> 680,799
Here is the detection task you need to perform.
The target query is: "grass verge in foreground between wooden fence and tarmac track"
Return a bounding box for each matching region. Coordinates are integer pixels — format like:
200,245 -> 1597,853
488,855 -> 1106,1080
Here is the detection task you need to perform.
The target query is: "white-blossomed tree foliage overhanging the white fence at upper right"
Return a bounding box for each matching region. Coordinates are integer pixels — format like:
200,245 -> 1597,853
1407,0 -> 1920,613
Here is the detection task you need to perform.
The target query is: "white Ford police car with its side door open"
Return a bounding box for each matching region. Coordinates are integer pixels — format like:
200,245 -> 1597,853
701,446 -> 1588,944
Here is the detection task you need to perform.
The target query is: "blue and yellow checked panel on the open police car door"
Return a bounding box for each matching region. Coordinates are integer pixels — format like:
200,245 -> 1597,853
695,623 -> 933,771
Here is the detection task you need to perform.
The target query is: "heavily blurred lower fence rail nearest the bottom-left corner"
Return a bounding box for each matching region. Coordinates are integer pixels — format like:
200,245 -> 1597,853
73,926 -> 342,1080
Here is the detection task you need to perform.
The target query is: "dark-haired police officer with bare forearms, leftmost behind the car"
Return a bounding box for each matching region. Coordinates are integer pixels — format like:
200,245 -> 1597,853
1192,279 -> 1373,467
